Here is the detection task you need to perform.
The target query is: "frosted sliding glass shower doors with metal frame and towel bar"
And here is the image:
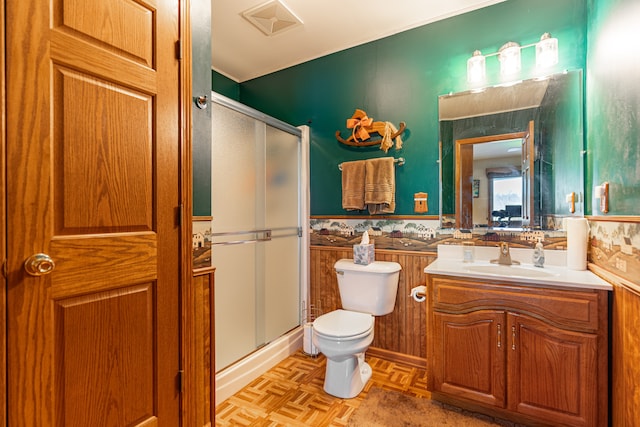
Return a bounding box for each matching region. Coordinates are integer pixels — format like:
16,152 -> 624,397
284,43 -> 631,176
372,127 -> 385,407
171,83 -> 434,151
211,93 -> 309,402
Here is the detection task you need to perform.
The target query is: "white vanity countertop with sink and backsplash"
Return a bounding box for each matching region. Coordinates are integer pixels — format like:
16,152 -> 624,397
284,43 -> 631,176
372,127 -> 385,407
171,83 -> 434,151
424,245 -> 613,291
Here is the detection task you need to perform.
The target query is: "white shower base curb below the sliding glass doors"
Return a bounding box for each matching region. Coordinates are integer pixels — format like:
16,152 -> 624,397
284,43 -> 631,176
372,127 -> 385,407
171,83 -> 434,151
215,327 -> 303,406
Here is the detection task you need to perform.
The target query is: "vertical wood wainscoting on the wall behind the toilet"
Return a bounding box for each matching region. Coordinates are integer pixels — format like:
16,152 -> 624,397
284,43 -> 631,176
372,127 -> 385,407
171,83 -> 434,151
310,246 -> 437,367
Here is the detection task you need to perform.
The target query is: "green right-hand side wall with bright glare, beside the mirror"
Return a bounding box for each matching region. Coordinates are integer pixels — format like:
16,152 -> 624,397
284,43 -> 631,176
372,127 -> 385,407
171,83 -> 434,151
586,0 -> 640,215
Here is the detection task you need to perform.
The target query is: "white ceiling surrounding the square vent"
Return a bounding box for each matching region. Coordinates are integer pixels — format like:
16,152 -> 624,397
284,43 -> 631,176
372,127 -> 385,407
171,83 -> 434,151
211,0 -> 505,82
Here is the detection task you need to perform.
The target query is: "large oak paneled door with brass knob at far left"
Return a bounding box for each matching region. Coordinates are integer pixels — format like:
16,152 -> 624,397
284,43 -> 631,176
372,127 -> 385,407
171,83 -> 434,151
5,0 -> 181,427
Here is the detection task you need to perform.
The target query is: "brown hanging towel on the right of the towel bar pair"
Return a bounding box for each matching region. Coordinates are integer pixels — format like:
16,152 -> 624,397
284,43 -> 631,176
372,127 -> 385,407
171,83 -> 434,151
364,157 -> 396,215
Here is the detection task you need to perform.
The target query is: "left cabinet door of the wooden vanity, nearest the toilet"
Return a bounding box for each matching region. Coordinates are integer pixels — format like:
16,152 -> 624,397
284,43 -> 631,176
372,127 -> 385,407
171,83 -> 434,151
432,310 -> 506,407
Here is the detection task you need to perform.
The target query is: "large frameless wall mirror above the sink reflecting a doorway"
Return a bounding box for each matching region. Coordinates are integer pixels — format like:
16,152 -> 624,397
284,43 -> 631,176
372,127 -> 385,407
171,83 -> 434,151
438,70 -> 584,230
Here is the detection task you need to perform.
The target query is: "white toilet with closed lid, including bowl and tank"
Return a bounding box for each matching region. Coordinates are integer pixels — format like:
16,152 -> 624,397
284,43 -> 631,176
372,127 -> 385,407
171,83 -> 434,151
313,259 -> 402,398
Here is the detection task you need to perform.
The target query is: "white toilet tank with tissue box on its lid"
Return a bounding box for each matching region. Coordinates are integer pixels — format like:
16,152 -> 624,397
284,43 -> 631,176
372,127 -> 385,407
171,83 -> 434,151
334,259 -> 402,316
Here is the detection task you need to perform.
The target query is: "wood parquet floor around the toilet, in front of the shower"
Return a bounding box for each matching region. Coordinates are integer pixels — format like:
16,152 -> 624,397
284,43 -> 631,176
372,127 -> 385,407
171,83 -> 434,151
216,351 -> 429,427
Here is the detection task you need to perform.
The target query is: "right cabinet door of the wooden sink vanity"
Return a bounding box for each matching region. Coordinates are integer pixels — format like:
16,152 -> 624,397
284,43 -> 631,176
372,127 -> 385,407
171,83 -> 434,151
507,313 -> 598,426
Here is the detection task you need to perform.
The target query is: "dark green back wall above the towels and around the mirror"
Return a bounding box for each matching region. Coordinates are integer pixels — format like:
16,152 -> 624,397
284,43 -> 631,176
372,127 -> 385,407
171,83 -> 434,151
239,0 -> 587,215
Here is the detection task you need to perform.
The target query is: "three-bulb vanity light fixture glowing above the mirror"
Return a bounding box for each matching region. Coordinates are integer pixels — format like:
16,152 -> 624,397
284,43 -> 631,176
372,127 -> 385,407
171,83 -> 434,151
467,33 -> 558,85
